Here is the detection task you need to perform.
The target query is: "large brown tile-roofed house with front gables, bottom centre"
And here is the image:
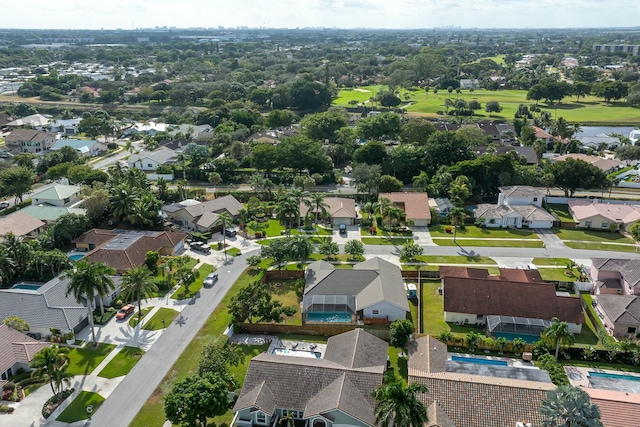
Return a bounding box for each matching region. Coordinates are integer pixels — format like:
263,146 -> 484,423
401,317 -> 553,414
233,329 -> 388,427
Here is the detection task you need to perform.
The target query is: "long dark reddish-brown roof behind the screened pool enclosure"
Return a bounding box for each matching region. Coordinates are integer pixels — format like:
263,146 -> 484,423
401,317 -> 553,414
442,270 -> 584,324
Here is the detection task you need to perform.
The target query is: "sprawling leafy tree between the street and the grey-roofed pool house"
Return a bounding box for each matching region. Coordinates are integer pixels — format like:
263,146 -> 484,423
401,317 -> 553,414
228,281 -> 296,323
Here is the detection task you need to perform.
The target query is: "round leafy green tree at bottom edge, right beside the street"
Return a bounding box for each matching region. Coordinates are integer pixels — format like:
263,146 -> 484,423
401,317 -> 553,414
164,374 -> 229,427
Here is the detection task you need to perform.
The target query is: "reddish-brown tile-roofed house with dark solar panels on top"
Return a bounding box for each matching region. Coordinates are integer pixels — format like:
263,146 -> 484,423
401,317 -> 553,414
73,228 -> 187,274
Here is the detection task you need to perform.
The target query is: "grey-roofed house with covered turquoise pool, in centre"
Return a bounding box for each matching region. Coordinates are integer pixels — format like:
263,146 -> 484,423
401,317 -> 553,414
302,257 -> 409,324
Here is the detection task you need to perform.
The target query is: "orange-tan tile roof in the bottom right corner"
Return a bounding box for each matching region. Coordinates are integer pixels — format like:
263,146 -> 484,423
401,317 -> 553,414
583,388 -> 640,427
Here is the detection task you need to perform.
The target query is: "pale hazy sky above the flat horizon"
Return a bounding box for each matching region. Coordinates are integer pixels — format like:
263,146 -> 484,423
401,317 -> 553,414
5,0 -> 640,29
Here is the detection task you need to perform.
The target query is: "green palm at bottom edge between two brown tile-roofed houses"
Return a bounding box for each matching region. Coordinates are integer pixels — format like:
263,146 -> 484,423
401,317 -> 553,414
372,379 -> 428,427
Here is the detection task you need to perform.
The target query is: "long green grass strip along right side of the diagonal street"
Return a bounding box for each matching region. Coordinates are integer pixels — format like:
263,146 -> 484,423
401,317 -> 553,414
130,268 -> 262,426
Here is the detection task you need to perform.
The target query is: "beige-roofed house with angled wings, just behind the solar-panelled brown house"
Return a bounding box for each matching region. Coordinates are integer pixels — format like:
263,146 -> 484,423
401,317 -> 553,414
162,195 -> 243,232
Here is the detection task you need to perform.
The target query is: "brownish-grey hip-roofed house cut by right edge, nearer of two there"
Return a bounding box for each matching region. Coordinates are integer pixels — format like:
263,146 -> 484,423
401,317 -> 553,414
595,294 -> 640,338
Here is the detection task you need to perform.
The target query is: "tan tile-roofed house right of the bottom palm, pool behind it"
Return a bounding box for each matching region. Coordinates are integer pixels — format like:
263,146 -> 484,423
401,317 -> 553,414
408,336 -> 556,427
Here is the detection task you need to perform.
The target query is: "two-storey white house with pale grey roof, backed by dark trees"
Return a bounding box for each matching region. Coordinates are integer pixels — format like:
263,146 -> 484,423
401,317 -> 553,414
473,185 -> 556,228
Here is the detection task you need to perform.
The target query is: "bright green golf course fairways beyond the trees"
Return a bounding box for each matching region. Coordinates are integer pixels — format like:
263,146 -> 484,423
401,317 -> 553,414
333,86 -> 640,125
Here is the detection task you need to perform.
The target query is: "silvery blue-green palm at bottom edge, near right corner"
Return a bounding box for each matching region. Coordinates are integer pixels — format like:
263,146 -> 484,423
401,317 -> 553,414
540,385 -> 602,427
